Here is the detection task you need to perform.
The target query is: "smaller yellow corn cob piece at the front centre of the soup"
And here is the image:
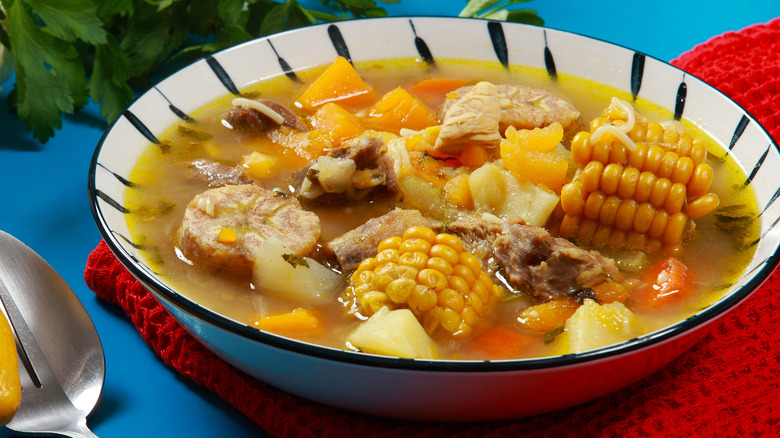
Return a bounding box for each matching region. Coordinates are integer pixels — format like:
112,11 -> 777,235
341,227 -> 503,338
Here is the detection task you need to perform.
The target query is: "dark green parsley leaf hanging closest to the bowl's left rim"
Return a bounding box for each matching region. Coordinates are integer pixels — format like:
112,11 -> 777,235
87,35 -> 133,121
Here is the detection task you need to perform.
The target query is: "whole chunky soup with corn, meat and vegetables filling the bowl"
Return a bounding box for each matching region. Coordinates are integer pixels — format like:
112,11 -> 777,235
127,58 -> 758,360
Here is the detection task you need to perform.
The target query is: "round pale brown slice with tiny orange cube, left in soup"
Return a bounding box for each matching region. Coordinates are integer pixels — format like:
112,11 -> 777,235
176,184 -> 320,276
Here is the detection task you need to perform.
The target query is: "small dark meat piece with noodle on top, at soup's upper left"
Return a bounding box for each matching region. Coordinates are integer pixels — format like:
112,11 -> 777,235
225,98 -> 308,134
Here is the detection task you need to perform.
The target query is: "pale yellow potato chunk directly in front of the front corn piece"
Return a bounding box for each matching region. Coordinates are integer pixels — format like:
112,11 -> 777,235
347,307 -> 436,359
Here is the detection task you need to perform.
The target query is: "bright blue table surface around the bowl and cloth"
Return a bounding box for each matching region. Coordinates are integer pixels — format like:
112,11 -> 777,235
0,0 -> 780,438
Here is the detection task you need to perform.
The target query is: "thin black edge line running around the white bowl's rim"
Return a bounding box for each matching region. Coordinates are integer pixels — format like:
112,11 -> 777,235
87,15 -> 780,372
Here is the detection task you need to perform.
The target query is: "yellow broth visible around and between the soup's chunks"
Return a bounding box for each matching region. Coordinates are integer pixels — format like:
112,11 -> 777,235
126,59 -> 757,359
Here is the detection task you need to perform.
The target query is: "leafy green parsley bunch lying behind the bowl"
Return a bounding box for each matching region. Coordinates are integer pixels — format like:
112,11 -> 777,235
0,0 -> 541,142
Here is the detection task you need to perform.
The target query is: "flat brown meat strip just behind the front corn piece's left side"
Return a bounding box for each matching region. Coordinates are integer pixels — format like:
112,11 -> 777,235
324,208 -> 431,272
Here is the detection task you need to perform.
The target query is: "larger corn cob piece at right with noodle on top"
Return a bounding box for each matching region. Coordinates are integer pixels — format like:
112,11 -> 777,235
560,99 -> 718,252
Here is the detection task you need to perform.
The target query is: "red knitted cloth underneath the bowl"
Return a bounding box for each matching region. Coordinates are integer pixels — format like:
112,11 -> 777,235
84,19 -> 780,438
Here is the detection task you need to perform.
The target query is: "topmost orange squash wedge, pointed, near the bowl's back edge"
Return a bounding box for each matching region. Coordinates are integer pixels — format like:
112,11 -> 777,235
297,56 -> 377,114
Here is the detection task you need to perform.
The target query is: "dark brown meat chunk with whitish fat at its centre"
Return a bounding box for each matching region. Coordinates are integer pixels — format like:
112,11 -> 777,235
292,136 -> 401,205
